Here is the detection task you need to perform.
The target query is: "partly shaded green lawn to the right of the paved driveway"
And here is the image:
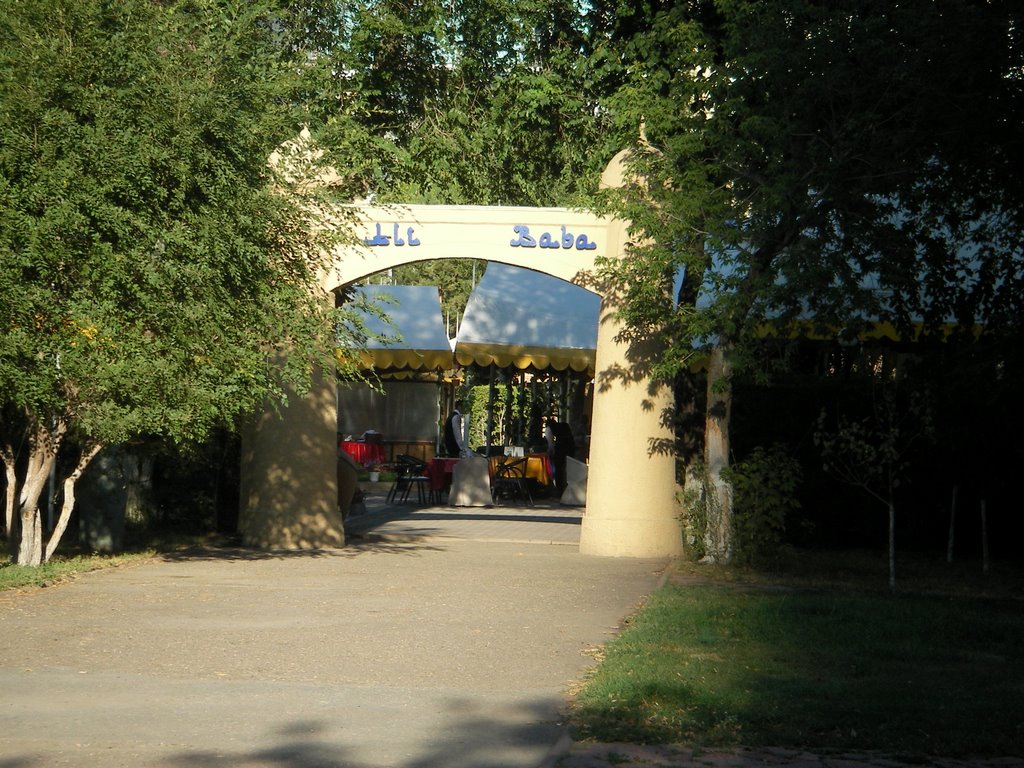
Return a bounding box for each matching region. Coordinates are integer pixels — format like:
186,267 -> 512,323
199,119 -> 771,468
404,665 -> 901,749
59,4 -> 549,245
573,552 -> 1024,759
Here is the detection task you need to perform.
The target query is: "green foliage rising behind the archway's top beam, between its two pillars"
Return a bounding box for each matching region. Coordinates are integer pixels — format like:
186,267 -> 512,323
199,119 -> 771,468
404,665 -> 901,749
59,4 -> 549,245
331,0 -> 607,205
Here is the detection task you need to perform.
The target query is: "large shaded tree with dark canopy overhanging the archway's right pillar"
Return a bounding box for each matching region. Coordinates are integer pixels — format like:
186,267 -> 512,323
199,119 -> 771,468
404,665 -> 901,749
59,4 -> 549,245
589,0 -> 1024,559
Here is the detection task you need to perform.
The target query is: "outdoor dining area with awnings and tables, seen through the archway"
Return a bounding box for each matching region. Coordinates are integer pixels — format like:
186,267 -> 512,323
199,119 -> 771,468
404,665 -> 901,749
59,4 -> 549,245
338,263 -> 599,518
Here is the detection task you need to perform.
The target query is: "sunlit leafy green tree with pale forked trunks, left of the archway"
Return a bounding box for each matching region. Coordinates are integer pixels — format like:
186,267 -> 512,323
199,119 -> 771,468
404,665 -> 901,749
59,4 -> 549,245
0,0 -> 368,564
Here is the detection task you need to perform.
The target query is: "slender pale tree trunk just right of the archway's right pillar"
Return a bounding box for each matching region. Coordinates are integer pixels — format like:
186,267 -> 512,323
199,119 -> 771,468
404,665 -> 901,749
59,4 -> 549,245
705,346 -> 732,563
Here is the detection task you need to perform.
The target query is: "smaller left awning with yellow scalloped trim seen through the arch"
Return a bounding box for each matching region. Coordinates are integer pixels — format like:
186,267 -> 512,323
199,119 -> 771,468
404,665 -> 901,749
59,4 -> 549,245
355,285 -> 453,371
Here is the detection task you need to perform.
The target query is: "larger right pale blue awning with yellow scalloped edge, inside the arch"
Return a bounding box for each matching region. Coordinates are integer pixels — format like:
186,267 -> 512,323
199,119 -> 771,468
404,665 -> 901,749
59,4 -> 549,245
455,262 -> 601,374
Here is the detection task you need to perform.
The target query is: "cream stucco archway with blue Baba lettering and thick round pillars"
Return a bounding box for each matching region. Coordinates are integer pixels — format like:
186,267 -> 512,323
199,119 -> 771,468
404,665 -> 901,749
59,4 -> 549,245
240,198 -> 682,557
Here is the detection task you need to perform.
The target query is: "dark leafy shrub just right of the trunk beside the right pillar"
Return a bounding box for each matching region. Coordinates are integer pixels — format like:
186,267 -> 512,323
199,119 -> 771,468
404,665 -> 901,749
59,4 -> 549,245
722,445 -> 802,564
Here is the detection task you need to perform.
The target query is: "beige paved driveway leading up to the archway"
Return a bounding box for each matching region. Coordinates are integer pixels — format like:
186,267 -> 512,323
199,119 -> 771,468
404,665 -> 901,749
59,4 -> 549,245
0,504 -> 666,768
